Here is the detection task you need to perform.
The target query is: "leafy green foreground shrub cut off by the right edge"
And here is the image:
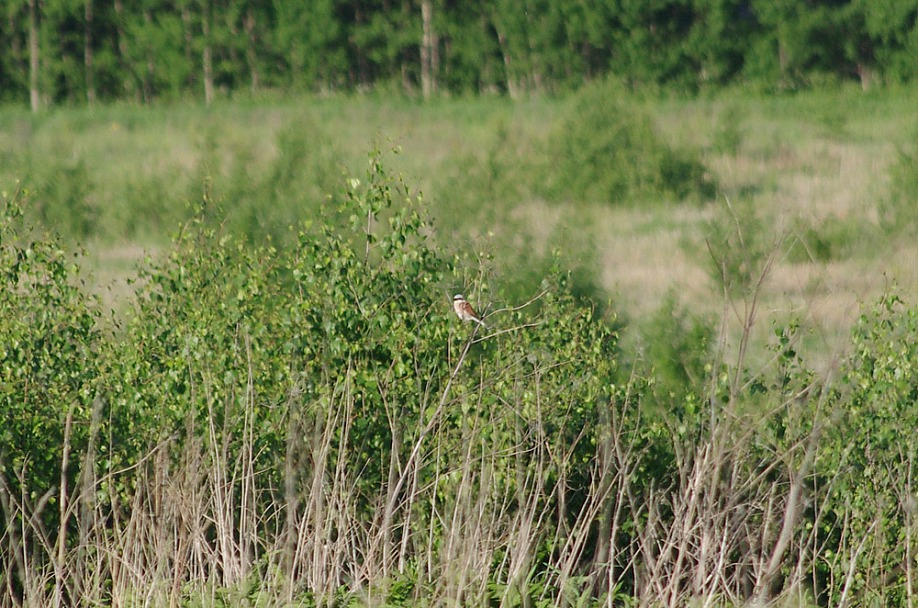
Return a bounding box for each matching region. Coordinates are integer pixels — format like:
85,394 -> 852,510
816,294 -> 918,605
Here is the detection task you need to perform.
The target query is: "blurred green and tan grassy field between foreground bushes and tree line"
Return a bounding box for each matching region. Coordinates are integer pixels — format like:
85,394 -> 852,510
0,83 -> 918,364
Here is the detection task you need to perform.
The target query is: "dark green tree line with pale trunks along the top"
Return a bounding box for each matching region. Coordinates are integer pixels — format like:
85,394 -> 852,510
0,0 -> 918,110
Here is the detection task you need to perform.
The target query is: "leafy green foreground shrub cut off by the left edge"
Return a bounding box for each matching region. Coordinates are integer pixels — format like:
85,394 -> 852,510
0,193 -> 101,556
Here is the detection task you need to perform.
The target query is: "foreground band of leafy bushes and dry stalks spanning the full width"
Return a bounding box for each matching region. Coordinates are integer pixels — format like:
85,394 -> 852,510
0,154 -> 918,606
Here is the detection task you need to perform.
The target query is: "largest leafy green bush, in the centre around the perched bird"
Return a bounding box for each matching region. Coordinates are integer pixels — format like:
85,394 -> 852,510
86,150 -> 636,604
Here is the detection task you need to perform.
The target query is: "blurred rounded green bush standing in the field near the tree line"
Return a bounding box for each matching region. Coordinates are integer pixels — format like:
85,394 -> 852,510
546,80 -> 714,204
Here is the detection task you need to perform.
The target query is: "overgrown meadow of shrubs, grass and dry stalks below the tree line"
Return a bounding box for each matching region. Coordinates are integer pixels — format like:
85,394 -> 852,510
0,82 -> 918,606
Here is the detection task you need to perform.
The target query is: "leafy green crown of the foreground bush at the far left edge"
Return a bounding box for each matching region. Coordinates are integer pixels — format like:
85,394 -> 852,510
0,192 -> 101,468
